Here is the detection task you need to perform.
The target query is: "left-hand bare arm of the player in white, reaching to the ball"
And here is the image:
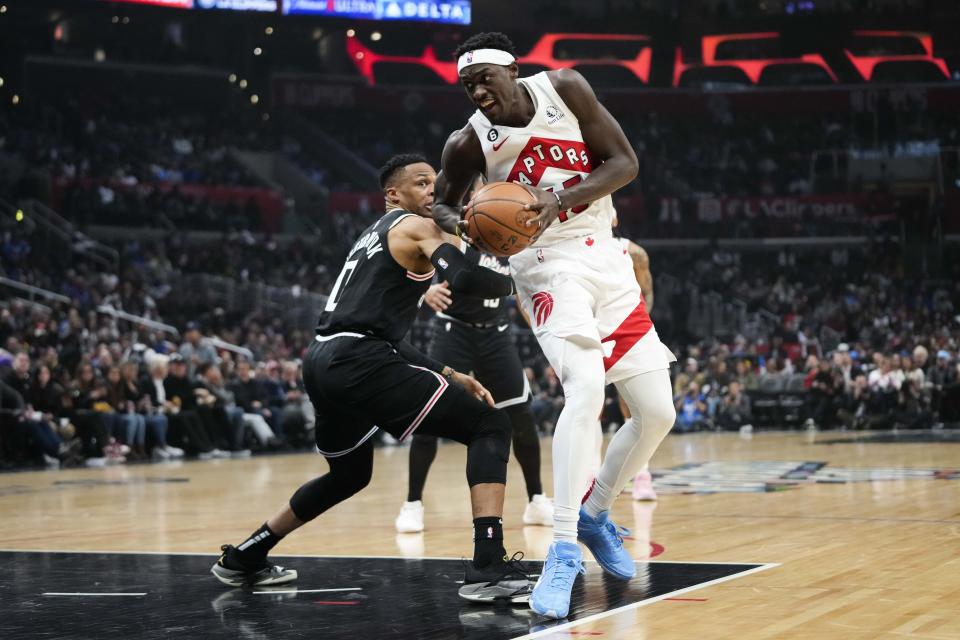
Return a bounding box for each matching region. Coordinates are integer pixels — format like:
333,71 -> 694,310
433,125 -> 486,235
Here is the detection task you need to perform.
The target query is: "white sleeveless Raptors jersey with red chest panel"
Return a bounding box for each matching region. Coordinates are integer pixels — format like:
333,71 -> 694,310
470,72 -> 615,246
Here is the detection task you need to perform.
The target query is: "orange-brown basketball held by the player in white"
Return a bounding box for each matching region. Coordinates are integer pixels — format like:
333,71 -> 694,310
465,182 -> 537,256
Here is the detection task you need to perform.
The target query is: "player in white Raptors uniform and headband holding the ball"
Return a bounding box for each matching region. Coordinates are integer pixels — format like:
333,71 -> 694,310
433,33 -> 675,618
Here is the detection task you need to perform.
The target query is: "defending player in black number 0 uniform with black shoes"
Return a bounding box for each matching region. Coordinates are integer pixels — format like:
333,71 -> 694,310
211,155 -> 532,602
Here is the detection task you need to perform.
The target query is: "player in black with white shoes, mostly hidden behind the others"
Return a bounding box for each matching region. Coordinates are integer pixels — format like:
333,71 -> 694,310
395,178 -> 553,533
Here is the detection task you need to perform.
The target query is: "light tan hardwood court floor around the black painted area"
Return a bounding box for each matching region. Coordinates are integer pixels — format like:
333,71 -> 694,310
0,432 -> 960,640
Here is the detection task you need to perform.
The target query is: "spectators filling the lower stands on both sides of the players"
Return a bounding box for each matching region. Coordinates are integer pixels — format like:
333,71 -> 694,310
0,212 -> 960,465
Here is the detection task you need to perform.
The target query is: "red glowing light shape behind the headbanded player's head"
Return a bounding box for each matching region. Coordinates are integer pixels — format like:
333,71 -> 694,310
347,29 -> 652,85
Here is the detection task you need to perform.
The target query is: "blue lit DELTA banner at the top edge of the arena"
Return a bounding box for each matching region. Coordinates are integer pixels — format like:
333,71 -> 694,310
283,0 -> 471,24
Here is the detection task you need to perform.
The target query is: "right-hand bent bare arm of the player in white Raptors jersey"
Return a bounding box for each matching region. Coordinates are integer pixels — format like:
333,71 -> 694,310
516,69 -> 640,235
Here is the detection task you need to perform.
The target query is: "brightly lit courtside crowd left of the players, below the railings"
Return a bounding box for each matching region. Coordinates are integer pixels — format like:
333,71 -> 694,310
0,302 -> 313,466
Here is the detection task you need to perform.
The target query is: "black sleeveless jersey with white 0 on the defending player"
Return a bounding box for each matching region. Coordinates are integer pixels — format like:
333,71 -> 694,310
317,209 -> 434,343
